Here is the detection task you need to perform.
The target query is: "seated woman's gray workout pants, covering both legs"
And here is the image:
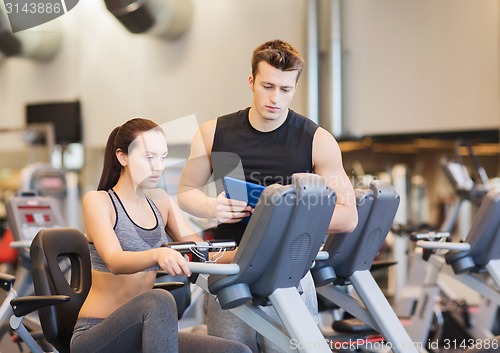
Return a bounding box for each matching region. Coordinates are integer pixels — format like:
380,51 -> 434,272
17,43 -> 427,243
71,289 -> 250,353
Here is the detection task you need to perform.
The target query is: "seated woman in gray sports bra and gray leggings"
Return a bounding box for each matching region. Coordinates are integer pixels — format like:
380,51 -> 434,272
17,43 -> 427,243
71,118 -> 249,353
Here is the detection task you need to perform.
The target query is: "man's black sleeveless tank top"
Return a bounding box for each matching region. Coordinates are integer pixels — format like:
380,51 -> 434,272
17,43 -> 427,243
211,108 -> 318,243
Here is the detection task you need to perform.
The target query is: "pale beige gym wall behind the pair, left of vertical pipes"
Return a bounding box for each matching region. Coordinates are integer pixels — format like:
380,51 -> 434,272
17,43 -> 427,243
0,0 -> 307,150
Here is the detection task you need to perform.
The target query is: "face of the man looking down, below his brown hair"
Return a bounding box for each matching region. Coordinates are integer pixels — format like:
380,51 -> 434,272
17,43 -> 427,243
248,61 -> 298,124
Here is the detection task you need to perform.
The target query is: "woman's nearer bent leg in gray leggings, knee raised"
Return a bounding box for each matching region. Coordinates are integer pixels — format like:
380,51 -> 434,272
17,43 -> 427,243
71,289 -> 178,353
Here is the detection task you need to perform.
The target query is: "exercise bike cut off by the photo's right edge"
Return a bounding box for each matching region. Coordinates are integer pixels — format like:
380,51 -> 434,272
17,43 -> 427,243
410,187 -> 500,350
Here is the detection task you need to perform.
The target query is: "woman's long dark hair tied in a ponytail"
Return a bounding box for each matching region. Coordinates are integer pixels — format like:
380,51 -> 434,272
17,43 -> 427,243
97,118 -> 158,190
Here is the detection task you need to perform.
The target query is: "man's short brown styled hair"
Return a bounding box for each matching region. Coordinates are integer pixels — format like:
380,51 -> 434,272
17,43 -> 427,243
252,39 -> 304,81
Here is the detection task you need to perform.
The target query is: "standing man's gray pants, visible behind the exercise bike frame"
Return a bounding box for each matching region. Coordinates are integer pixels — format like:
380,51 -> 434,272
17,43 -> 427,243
205,272 -> 319,353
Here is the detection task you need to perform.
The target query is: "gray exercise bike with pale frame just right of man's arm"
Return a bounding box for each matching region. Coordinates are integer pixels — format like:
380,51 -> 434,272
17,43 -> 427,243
311,180 -> 424,353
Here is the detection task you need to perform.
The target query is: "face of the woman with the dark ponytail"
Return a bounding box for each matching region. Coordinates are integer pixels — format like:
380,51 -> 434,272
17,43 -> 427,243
128,130 -> 168,189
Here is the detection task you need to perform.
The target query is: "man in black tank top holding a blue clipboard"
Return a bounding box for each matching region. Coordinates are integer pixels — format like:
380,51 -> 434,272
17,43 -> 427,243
177,40 -> 357,352
